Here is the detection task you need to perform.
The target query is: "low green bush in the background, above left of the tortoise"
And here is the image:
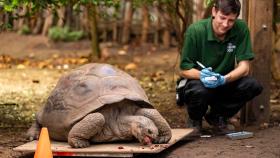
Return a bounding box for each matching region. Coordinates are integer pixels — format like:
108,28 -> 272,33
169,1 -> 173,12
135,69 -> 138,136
48,27 -> 84,42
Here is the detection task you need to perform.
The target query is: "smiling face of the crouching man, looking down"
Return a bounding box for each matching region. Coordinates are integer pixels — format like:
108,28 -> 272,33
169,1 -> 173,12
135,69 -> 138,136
212,7 -> 237,37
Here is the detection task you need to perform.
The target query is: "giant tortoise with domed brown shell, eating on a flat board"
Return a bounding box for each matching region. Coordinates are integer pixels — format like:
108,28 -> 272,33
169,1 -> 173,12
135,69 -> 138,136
27,63 -> 171,148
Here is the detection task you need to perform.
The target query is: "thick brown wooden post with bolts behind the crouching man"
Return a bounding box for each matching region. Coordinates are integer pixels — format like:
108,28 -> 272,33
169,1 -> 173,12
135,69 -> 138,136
248,0 -> 273,125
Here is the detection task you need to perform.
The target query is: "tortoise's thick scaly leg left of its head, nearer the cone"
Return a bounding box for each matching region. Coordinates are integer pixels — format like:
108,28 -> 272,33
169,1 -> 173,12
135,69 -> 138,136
68,113 -> 105,148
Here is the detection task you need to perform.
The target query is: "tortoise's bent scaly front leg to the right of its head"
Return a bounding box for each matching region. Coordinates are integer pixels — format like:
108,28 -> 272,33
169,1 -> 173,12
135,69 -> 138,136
136,108 -> 172,143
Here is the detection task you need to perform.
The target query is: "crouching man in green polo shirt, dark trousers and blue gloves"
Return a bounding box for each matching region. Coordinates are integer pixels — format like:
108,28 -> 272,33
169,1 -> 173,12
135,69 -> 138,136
180,0 -> 262,133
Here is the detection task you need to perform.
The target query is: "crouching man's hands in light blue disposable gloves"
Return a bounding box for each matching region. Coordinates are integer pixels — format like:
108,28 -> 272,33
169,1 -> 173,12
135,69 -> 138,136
200,67 -> 226,88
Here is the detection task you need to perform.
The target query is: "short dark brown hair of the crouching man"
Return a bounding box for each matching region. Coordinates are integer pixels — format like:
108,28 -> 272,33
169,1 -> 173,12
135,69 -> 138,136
214,0 -> 241,17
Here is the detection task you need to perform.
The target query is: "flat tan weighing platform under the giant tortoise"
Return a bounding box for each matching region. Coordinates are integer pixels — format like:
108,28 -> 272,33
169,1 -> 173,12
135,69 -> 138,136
13,128 -> 193,157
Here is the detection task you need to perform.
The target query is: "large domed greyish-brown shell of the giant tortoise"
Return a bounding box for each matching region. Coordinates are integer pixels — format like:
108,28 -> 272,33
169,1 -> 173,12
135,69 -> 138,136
37,63 -> 153,131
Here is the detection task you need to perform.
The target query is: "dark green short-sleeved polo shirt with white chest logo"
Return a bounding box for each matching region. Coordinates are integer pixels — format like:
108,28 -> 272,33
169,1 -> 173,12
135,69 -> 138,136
180,18 -> 254,75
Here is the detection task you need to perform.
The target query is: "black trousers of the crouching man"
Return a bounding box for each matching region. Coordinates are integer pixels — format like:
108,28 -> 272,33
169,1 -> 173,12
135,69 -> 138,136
184,77 -> 263,120
